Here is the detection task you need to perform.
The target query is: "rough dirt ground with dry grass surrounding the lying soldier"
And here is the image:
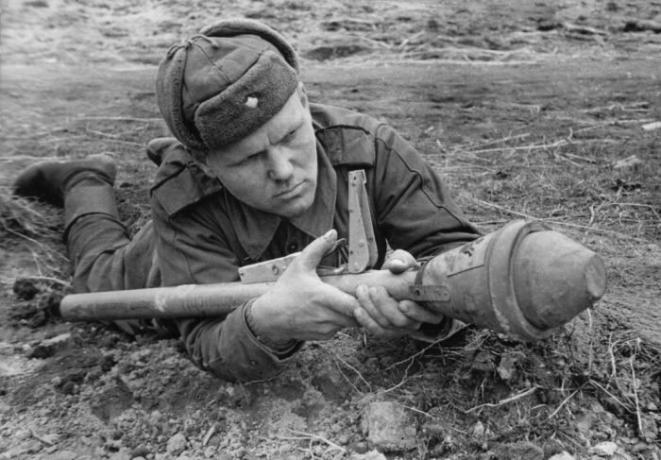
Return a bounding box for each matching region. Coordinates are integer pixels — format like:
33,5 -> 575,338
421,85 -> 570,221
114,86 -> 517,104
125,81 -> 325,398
0,0 -> 661,460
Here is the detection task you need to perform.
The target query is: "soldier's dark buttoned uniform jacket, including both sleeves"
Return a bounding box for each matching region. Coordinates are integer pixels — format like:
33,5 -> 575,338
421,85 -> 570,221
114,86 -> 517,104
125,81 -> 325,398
151,104 -> 477,380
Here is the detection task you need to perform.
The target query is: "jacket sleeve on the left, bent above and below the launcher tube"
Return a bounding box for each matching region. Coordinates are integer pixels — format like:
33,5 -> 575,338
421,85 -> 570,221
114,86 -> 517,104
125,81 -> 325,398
152,194 -> 298,381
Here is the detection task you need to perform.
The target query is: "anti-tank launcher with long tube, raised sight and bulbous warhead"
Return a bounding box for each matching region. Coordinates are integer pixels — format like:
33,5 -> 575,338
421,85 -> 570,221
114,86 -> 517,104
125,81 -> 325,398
60,171 -> 606,339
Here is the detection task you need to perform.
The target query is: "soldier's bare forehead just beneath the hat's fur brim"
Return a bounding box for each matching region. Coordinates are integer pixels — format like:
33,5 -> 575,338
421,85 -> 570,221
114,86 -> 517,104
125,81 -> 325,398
209,91 -> 307,161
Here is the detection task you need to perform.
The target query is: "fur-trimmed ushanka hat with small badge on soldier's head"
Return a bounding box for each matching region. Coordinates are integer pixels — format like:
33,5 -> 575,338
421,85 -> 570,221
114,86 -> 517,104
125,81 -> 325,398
156,19 -> 298,152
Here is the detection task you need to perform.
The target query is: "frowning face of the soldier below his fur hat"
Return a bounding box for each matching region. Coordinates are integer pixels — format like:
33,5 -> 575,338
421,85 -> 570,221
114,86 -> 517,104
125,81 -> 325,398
205,85 -> 317,218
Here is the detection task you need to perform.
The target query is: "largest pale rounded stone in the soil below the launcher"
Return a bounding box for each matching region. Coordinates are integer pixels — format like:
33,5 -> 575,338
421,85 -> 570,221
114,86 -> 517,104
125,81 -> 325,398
362,401 -> 417,452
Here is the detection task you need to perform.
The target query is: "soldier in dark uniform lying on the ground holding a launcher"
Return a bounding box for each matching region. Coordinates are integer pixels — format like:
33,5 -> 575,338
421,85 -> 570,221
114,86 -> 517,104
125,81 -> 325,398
15,19 -> 478,380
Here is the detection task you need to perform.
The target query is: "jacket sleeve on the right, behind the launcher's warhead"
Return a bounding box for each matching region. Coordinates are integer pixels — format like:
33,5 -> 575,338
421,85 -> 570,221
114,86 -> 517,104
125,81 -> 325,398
371,125 -> 479,258
